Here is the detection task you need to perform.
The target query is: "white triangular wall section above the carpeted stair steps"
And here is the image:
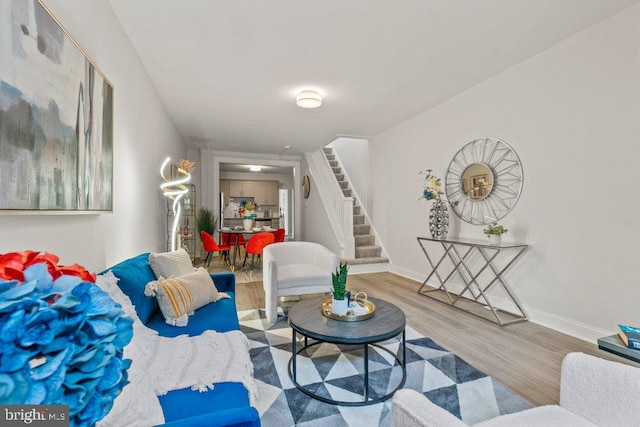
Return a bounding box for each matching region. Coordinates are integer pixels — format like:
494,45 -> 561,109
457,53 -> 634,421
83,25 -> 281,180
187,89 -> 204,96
329,137 -> 372,216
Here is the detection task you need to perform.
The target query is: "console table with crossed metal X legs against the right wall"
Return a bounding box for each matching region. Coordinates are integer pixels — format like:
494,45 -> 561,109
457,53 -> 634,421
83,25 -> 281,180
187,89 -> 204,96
418,237 -> 529,326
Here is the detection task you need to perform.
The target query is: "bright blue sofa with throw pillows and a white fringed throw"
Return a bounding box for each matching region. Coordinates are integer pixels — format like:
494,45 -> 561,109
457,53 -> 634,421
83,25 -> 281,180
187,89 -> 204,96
107,253 -> 260,427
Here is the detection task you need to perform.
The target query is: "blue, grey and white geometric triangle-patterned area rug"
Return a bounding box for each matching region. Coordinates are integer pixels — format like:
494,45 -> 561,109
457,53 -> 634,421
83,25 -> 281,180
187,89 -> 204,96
238,308 -> 531,427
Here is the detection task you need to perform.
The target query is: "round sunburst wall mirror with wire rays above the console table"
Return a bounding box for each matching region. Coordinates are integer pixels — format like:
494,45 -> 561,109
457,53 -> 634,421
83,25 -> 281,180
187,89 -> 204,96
445,138 -> 523,225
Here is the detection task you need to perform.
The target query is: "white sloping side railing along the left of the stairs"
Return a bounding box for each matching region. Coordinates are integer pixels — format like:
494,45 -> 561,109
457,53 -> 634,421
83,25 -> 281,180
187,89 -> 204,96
305,149 -> 355,259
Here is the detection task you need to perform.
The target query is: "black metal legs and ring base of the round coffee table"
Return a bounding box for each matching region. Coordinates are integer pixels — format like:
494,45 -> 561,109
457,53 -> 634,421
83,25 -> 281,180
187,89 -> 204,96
288,330 -> 407,406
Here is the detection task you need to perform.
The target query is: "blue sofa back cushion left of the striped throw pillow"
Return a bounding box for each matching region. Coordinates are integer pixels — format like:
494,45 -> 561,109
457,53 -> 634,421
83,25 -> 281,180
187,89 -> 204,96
105,253 -> 160,323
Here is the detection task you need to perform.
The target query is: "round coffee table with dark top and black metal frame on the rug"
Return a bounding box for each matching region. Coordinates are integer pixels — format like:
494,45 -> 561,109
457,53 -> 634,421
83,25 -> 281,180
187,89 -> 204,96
289,296 -> 407,406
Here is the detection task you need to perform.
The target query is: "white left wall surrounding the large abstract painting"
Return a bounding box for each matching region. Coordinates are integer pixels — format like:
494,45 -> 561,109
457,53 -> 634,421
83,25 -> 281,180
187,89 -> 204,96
0,0 -> 186,271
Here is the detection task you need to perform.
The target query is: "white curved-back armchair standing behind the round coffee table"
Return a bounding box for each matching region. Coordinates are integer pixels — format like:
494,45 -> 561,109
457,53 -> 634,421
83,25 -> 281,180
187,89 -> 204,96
262,242 -> 340,322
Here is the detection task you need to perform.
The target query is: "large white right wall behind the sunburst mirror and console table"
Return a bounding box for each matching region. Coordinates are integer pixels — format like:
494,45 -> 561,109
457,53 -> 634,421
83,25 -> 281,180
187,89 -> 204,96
370,5 -> 640,340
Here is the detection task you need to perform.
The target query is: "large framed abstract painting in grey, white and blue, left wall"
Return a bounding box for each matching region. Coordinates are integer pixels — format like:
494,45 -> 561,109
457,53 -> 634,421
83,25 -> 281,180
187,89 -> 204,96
0,0 -> 113,213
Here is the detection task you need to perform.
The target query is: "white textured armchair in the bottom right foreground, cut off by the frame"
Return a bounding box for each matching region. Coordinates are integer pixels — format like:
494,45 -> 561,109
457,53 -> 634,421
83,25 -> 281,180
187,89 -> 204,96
391,353 -> 640,427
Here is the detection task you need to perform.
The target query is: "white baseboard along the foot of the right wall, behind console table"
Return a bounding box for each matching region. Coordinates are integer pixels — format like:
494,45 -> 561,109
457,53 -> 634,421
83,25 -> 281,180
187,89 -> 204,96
389,264 -> 615,344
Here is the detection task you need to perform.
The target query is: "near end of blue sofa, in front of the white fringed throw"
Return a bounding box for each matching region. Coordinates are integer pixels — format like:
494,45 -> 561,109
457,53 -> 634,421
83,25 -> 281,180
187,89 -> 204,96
158,383 -> 260,427
